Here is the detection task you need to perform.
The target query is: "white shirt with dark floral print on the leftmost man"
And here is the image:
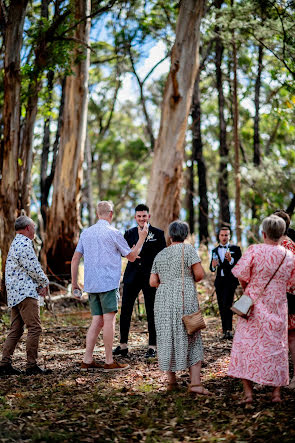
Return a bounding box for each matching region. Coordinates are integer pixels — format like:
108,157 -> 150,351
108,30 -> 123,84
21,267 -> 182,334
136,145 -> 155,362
5,234 -> 49,307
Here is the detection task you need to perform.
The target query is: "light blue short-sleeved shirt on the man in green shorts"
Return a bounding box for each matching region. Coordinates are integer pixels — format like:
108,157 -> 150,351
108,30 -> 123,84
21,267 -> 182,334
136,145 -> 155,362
76,220 -> 131,293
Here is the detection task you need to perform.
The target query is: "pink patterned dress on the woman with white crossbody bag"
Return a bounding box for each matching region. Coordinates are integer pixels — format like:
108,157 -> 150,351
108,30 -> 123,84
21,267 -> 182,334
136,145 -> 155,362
228,244 -> 295,386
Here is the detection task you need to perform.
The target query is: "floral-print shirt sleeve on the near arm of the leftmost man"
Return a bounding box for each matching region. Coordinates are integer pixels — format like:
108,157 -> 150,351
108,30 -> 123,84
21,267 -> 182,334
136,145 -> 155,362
18,243 -> 49,287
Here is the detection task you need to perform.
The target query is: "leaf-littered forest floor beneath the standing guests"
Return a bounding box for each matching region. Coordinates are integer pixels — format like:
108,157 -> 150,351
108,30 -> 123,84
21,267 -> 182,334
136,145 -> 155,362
0,292 -> 295,443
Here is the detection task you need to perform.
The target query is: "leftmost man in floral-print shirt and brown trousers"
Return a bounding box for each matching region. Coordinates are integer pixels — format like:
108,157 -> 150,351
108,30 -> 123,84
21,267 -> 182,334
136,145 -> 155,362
0,216 -> 51,376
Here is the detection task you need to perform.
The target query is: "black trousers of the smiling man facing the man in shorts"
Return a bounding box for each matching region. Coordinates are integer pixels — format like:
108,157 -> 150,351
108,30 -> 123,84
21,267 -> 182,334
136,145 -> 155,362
120,276 -> 156,346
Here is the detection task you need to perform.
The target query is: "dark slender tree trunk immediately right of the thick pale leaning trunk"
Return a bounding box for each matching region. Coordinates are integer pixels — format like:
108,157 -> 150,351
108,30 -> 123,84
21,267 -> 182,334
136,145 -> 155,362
192,72 -> 209,245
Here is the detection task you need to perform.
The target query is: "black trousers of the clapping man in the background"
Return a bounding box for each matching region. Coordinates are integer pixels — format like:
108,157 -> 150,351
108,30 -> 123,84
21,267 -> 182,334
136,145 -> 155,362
215,277 -> 236,333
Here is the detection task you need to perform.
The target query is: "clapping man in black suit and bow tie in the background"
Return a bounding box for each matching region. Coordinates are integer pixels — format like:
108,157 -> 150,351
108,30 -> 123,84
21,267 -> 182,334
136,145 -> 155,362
210,227 -> 242,339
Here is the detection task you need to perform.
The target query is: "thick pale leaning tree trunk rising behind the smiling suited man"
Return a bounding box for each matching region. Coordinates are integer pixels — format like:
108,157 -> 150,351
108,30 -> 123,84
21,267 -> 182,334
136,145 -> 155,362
147,0 -> 205,229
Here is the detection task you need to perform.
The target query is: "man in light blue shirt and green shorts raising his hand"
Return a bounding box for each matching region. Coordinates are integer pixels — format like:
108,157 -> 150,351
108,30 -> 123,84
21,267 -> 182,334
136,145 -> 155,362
72,201 -> 148,371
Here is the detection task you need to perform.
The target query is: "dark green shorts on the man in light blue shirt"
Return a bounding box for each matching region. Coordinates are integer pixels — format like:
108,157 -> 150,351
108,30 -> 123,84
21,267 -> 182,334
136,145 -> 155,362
88,289 -> 120,315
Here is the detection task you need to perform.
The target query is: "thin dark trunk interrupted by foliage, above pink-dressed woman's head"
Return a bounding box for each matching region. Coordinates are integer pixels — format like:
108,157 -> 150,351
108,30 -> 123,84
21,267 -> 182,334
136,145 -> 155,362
252,45 -> 263,238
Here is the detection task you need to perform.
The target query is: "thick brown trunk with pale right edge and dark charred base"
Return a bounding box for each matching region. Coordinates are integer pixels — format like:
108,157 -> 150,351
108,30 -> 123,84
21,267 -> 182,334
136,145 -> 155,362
45,0 -> 90,278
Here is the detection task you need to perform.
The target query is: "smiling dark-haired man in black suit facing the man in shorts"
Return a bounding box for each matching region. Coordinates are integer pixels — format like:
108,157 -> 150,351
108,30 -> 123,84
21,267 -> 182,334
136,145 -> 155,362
113,204 -> 166,358
